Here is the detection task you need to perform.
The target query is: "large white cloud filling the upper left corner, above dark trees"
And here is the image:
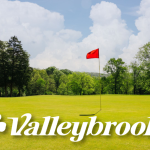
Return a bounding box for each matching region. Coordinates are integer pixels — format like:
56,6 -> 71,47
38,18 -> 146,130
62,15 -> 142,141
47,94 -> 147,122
0,0 -> 64,57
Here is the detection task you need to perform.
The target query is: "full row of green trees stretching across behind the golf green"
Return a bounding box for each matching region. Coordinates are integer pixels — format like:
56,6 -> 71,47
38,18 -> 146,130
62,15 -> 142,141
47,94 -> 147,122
0,36 -> 150,97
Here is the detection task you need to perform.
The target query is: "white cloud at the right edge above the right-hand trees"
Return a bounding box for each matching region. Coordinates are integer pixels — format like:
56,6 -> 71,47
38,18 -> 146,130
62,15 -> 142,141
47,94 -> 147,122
120,0 -> 150,64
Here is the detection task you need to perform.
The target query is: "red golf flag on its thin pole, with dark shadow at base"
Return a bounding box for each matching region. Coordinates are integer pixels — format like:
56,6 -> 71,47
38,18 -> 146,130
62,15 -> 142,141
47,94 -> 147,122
80,48 -> 101,116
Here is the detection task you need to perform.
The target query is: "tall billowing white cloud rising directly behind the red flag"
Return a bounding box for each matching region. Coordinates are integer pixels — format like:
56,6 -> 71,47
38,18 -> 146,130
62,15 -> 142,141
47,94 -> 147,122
31,2 -> 130,72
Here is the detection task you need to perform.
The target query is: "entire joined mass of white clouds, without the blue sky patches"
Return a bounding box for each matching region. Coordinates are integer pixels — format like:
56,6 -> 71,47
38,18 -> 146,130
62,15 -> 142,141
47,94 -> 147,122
0,0 -> 150,72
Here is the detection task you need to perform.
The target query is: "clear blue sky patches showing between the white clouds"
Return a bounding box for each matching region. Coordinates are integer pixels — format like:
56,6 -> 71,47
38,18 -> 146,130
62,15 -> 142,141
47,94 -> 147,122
10,0 -> 141,39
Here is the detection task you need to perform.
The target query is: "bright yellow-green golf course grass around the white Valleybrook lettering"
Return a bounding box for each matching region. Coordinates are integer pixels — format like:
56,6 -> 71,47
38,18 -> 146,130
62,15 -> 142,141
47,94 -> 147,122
0,95 -> 150,150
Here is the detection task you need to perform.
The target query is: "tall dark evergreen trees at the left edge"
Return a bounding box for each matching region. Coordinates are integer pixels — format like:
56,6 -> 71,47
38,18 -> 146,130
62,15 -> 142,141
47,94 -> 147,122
0,36 -> 32,96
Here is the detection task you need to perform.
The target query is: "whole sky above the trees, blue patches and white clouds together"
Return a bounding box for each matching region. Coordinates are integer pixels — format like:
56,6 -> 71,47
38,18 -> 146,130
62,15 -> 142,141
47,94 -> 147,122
0,0 -> 150,72
